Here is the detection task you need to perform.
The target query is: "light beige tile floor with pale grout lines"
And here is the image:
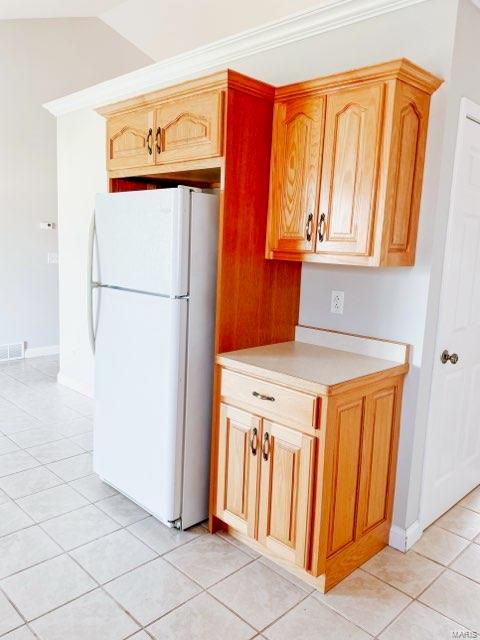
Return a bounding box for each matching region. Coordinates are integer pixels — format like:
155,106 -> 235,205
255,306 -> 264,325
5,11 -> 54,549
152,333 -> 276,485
0,356 -> 480,640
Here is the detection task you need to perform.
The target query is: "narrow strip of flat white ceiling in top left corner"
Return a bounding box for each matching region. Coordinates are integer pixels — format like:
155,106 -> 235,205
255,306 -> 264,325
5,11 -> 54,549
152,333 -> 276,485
0,0 -> 123,20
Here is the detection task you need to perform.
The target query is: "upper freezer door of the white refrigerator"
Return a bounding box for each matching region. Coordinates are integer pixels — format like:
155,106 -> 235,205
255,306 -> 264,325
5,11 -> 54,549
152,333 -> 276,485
94,187 -> 190,297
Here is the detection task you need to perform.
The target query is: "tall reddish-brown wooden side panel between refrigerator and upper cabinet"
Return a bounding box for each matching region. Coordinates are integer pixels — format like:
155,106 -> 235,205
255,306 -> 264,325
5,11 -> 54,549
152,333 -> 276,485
215,88 -> 301,353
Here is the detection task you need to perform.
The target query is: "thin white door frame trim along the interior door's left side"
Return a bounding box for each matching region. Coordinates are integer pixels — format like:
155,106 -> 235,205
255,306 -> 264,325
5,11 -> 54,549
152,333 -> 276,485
419,97 -> 480,537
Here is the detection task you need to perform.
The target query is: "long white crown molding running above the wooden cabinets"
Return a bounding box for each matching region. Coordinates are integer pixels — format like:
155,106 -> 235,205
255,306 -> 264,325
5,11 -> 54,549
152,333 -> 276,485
43,0 -> 425,116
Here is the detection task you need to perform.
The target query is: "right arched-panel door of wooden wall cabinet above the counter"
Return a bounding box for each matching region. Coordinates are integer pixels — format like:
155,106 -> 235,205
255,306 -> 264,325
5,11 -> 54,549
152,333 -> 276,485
316,83 -> 384,256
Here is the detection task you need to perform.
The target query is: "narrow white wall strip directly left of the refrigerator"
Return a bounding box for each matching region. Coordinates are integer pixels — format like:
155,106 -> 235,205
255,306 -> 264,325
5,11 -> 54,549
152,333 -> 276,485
57,110 -> 108,396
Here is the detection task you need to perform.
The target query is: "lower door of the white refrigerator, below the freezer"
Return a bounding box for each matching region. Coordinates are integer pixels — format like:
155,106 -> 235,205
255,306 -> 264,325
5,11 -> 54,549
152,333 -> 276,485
94,288 -> 188,524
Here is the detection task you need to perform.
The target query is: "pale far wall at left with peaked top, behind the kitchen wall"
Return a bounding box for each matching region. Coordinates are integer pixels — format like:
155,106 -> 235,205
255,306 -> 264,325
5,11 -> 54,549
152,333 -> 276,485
0,18 -> 150,356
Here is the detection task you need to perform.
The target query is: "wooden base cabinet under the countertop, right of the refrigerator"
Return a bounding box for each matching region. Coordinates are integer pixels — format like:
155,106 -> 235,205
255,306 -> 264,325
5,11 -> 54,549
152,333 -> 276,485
211,365 -> 407,590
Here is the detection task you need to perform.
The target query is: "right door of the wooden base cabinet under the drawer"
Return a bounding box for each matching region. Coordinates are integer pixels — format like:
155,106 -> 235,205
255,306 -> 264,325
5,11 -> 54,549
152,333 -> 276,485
258,420 -> 314,567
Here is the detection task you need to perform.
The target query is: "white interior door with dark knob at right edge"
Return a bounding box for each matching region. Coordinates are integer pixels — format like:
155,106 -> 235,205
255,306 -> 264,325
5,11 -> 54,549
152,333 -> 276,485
421,100 -> 480,527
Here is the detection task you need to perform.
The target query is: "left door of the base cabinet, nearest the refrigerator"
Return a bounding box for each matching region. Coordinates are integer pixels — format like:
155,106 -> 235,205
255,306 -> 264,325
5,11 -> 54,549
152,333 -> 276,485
216,404 -> 261,538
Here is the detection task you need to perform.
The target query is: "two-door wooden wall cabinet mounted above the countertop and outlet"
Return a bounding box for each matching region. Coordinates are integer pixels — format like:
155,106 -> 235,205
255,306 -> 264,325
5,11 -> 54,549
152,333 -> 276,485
266,59 -> 441,266
